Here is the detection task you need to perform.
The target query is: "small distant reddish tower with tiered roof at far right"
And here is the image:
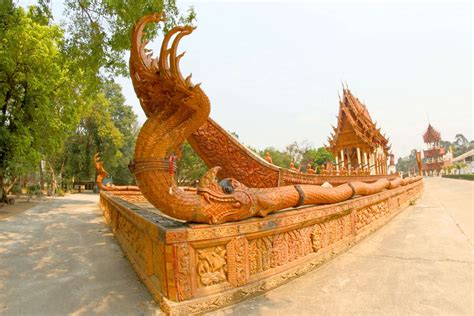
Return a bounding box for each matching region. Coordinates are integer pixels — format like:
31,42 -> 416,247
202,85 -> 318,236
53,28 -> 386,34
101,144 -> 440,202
423,124 -> 446,176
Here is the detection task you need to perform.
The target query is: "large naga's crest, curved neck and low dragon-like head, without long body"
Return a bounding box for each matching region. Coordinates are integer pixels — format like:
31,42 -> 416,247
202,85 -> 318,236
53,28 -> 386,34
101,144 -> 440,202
130,14 -> 262,223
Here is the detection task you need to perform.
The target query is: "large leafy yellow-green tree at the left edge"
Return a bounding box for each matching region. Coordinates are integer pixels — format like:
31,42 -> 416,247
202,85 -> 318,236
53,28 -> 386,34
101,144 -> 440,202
0,1 -> 82,199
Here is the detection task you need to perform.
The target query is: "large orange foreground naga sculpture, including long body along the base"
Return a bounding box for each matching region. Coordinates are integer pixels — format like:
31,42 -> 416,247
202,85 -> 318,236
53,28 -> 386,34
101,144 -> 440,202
130,14 -> 417,224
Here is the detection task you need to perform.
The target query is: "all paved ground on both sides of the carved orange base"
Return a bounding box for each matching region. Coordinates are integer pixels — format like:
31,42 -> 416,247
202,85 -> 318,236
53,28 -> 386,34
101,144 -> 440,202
0,179 -> 474,315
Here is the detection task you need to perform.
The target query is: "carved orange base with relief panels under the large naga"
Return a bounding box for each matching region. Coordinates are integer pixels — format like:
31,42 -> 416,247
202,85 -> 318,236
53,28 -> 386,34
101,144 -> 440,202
100,181 -> 423,315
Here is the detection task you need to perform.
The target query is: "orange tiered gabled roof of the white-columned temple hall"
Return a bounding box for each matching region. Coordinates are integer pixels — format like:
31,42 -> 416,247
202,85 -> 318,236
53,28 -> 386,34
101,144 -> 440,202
328,88 -> 390,154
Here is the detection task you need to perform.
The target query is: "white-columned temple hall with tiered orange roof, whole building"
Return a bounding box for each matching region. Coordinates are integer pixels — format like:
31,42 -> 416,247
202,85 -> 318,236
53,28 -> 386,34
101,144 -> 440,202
327,88 -> 390,175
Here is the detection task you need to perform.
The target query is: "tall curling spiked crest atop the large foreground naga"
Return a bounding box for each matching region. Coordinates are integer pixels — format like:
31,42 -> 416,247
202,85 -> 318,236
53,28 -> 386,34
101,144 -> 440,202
130,13 -> 210,150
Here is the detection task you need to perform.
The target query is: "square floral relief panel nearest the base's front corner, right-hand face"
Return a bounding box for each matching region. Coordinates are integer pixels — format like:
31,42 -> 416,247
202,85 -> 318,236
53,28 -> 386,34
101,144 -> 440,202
197,246 -> 227,287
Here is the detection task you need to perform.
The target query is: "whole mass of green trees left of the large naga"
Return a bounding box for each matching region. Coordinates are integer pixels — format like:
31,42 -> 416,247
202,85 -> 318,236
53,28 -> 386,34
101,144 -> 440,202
0,0 -> 189,197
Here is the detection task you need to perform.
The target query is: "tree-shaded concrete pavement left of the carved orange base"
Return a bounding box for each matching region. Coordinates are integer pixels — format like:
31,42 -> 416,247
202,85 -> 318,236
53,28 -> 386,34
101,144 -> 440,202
0,194 -> 159,315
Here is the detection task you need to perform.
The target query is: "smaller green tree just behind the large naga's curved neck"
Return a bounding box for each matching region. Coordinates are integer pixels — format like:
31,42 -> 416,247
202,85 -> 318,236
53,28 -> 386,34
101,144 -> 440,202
64,82 -> 138,184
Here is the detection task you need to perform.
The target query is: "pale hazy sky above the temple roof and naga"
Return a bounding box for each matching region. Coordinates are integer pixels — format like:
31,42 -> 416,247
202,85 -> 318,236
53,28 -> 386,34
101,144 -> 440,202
17,1 -> 473,157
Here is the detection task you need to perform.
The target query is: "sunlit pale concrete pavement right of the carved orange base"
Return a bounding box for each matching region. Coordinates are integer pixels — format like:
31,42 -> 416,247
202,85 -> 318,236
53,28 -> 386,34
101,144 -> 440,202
214,178 -> 474,315
